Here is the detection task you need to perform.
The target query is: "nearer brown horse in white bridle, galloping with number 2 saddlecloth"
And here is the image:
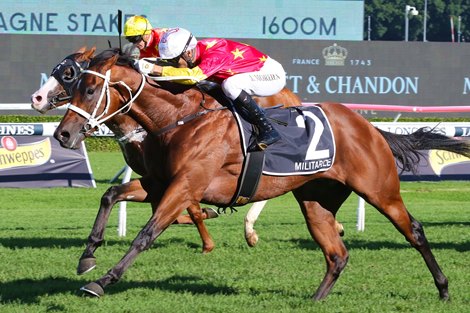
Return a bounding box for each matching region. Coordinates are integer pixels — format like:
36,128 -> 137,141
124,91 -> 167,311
54,50 -> 470,300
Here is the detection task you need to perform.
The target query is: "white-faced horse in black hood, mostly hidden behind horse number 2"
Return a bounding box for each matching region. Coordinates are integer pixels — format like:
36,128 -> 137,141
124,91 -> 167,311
31,47 -> 330,260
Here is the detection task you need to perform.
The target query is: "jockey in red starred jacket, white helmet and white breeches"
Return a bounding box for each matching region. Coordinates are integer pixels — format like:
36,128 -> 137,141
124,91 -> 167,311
139,28 -> 286,150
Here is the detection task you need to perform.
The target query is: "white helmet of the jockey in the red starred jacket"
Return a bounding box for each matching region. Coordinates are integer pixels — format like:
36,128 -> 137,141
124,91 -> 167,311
158,27 -> 197,59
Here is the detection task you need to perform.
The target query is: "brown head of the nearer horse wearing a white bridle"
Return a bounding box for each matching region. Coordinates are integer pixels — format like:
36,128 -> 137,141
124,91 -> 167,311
54,49 -> 145,149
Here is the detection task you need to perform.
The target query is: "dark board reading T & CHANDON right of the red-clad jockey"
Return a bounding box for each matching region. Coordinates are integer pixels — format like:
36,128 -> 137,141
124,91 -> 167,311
242,40 -> 470,110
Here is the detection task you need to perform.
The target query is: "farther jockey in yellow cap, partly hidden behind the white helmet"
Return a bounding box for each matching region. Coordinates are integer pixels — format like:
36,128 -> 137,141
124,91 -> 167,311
124,15 -> 168,59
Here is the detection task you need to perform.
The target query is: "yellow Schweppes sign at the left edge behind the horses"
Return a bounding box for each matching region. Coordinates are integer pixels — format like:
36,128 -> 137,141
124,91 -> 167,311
0,136 -> 52,171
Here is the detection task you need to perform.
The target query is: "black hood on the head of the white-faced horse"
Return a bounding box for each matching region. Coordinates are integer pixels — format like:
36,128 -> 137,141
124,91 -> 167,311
49,53 -> 90,108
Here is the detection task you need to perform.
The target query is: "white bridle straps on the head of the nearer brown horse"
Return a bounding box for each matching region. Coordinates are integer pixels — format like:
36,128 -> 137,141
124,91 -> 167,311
68,70 -> 145,131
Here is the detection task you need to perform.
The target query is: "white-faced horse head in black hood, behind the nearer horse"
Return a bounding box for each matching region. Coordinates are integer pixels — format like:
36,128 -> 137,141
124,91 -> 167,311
31,47 -> 96,113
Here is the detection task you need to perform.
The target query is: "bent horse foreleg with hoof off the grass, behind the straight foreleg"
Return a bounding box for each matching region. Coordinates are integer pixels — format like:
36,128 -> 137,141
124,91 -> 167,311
77,179 -> 151,275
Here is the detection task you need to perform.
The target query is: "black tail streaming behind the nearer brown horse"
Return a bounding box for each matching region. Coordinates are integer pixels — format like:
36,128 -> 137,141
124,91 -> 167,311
376,127 -> 470,174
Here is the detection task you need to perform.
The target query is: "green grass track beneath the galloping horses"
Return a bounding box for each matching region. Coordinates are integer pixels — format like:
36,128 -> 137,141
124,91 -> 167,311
0,152 -> 470,313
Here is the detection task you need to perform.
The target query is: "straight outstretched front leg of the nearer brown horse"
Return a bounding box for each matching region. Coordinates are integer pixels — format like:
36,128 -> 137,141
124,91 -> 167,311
80,183 -> 194,297
